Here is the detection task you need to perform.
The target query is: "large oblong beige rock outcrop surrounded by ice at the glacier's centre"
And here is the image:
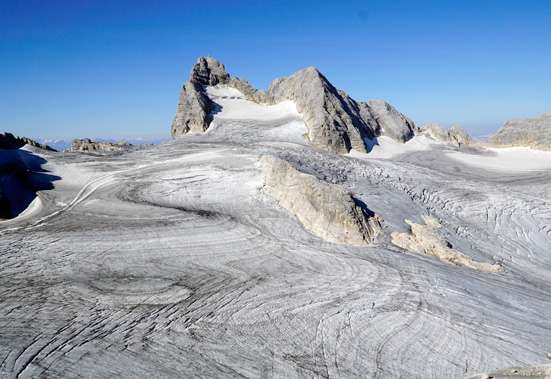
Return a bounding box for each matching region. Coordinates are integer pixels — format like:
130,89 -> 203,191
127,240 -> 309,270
260,156 -> 381,246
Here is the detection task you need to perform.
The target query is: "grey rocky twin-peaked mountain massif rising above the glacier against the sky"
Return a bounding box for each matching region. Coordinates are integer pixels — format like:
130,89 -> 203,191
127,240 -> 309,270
171,57 -> 418,154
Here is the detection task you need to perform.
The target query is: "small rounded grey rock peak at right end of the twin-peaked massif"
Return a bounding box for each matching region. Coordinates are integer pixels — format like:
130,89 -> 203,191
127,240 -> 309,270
368,100 -> 418,143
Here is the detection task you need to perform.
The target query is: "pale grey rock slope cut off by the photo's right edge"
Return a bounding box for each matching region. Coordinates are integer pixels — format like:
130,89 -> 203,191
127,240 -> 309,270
489,111 -> 551,150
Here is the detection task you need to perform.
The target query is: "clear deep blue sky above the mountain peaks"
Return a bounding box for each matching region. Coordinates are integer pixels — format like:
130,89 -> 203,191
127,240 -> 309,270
0,0 -> 551,139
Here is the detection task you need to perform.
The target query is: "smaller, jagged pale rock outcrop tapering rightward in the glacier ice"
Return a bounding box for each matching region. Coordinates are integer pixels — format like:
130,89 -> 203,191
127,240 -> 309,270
390,215 -> 503,272
